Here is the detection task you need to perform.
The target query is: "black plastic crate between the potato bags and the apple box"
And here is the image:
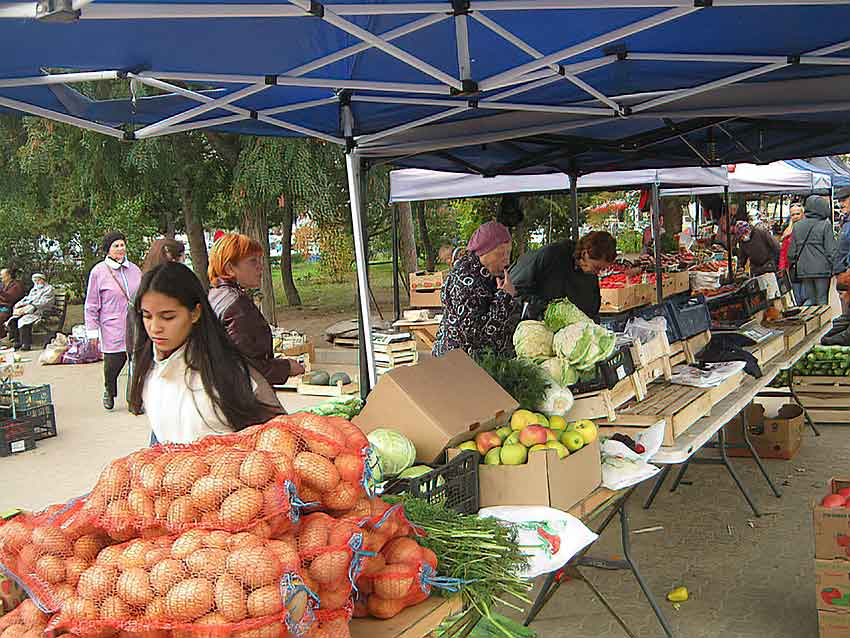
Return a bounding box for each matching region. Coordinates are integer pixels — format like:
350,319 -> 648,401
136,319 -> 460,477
384,450 -> 481,514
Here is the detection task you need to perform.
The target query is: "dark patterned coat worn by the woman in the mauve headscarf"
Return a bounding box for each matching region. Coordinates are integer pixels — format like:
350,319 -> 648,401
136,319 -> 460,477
433,253 -> 514,357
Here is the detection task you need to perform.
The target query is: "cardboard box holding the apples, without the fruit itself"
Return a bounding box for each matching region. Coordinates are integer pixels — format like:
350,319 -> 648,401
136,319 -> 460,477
449,439 -> 602,511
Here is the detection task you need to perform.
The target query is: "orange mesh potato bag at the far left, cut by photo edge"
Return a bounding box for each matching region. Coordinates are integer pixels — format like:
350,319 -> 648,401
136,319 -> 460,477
0,507 -> 113,612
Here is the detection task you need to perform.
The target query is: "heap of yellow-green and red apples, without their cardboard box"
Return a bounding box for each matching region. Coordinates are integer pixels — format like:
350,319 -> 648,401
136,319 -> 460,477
458,410 -> 597,465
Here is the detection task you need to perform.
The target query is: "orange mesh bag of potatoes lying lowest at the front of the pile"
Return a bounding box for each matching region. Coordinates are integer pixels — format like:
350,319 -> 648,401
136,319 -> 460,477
50,529 -> 360,638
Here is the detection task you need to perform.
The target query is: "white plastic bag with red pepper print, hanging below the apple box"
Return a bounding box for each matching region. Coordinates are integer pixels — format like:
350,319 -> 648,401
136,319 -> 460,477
478,505 -> 599,578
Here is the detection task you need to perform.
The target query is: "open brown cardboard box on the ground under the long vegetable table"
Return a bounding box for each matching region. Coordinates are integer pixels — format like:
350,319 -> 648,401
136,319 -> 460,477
726,403 -> 805,461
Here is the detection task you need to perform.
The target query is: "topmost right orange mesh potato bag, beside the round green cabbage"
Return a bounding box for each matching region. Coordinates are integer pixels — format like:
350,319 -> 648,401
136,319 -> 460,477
233,413 -> 373,513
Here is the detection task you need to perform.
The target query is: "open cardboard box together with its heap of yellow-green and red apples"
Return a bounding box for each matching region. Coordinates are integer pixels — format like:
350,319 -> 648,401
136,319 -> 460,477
449,410 -> 602,511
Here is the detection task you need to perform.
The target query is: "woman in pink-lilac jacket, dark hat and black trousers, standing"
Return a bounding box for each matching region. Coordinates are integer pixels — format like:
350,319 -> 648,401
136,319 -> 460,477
86,233 -> 142,410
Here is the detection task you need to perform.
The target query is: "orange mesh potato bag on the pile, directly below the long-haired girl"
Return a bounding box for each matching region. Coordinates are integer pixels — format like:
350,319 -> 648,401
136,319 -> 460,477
76,436 -> 300,541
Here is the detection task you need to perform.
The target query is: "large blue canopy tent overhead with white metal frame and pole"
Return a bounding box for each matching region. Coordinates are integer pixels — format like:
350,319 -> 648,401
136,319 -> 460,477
0,0 -> 850,396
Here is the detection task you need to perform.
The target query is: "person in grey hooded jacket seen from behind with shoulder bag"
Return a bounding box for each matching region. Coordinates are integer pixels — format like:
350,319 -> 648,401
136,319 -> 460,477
788,195 -> 840,306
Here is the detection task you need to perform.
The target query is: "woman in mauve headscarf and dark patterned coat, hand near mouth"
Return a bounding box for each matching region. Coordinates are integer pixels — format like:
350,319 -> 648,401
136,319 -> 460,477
433,222 -> 516,357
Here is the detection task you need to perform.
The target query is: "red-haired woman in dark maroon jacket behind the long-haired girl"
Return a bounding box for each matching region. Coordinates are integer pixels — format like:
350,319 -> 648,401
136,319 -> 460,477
208,233 -> 304,385
